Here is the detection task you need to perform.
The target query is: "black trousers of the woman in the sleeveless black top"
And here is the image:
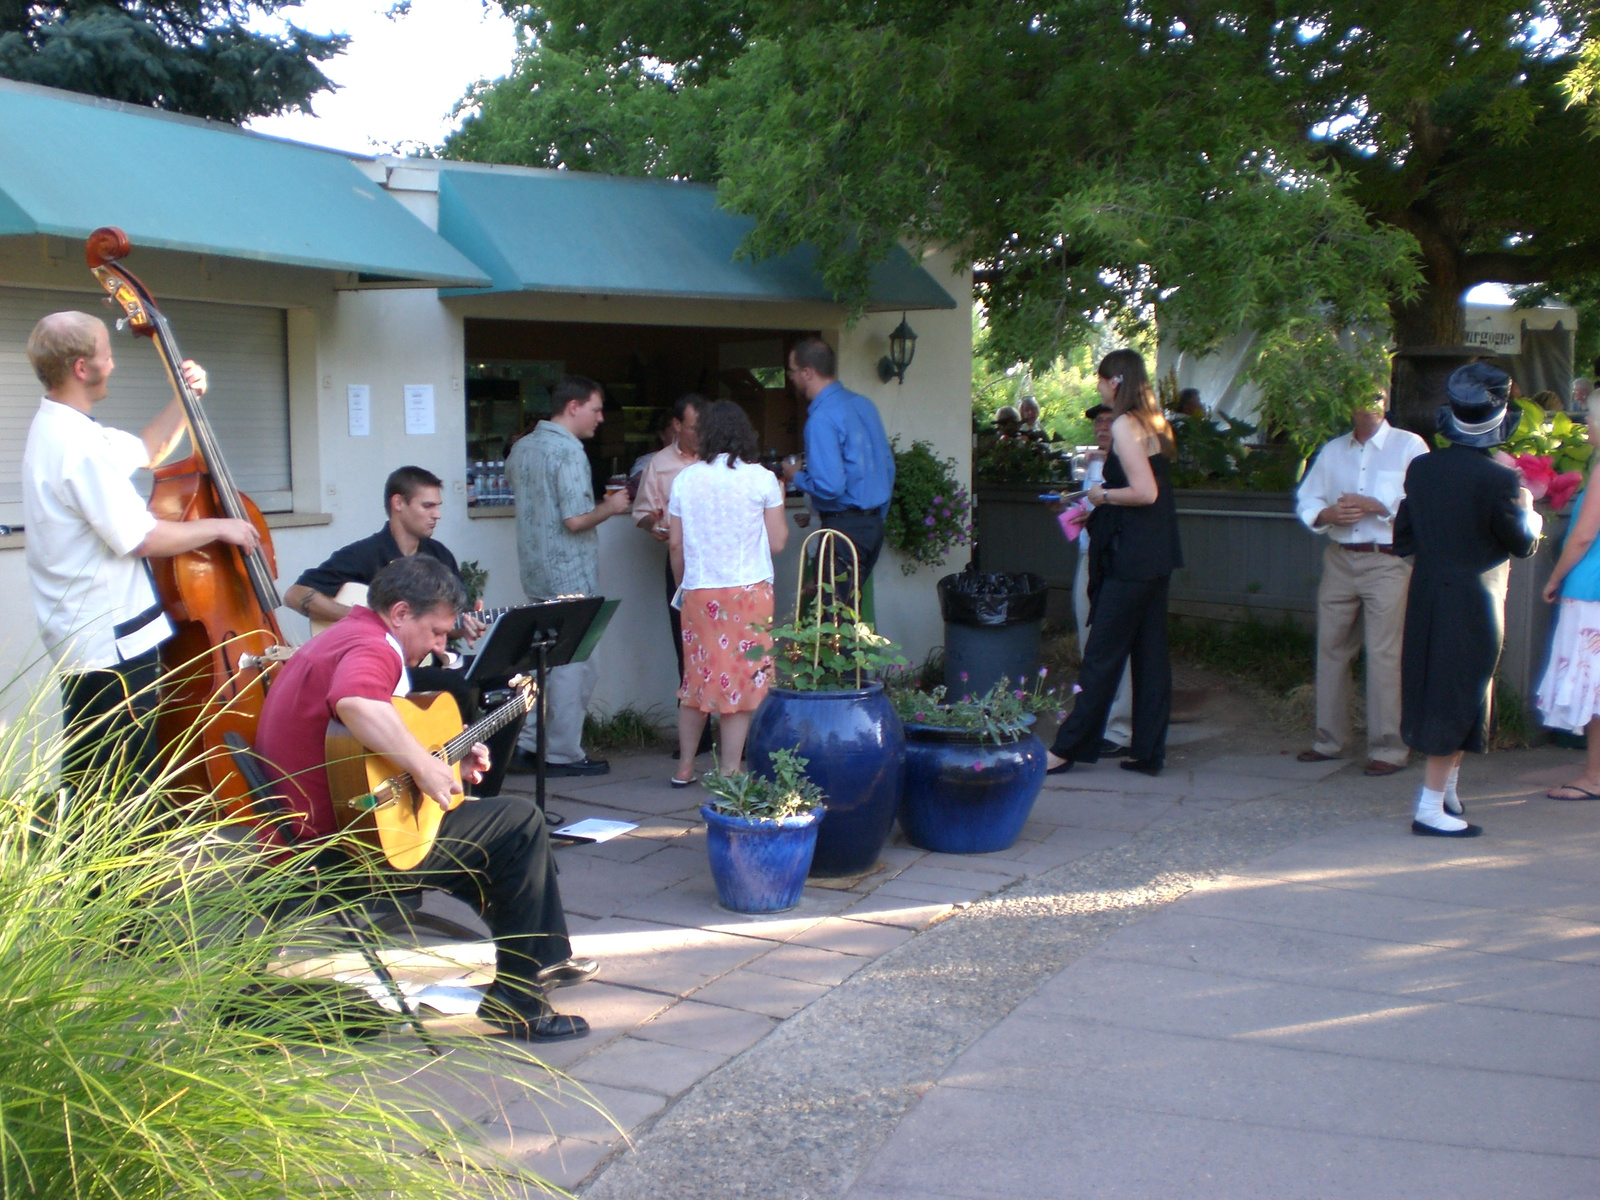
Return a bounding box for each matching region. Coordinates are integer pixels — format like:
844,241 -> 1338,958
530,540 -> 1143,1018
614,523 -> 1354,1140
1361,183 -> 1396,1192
1050,576 -> 1173,763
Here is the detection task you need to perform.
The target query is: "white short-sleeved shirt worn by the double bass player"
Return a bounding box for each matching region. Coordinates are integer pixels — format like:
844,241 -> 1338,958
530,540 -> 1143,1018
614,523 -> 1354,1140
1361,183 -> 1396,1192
22,397 -> 173,670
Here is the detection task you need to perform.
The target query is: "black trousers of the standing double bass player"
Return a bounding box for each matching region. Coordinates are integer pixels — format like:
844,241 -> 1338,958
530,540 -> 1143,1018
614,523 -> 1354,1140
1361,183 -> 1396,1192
61,648 -> 162,792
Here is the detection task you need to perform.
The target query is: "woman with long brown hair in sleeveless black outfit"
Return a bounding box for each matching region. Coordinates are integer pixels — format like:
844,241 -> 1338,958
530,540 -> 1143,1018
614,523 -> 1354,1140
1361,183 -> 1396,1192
1050,350 -> 1184,774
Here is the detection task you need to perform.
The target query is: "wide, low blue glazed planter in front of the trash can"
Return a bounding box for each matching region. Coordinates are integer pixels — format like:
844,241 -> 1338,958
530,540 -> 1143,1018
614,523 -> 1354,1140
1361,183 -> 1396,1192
899,725 -> 1045,854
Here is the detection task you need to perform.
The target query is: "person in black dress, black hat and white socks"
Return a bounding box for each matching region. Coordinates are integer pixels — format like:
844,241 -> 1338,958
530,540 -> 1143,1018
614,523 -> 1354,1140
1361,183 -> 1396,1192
1395,363 -> 1544,837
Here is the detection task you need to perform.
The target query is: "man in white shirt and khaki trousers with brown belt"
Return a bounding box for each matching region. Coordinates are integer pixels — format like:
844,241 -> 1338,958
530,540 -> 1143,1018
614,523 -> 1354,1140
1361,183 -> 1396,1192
1296,390 -> 1427,774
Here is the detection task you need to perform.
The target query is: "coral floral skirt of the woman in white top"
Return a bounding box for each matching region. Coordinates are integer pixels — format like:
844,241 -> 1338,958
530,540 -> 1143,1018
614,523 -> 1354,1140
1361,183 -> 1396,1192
678,582 -> 773,712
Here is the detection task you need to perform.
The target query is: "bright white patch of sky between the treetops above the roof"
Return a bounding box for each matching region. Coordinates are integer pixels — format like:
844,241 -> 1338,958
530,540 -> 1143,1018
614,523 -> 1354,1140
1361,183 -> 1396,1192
248,0 -> 517,154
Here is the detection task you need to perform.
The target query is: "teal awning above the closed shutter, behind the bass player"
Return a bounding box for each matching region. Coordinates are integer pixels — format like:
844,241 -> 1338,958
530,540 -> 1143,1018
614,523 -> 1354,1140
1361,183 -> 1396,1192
0,80 -> 488,286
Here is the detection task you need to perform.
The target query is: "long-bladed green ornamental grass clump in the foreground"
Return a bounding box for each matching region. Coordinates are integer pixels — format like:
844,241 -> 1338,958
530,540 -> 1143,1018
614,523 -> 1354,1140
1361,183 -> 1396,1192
0,682 -> 550,1200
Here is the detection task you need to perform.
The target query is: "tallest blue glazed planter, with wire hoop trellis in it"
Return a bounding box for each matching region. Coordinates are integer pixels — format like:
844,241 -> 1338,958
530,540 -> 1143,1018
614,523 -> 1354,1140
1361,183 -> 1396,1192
746,683 -> 906,875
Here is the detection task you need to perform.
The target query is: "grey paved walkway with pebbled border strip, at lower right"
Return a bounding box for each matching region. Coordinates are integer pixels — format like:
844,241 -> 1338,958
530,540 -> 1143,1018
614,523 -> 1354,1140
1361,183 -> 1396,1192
581,750 -> 1600,1200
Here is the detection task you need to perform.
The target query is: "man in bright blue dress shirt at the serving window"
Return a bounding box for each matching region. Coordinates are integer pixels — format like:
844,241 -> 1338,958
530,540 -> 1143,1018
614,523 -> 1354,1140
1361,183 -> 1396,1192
784,336 -> 894,598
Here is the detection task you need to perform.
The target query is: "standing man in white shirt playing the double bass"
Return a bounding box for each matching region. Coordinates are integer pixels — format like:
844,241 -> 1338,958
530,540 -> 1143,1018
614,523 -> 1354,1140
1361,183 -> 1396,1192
22,312 -> 259,787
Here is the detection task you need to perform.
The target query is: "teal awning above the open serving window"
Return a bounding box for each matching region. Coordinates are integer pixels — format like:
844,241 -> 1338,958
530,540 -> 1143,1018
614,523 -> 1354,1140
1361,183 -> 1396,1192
438,166 -> 955,310
